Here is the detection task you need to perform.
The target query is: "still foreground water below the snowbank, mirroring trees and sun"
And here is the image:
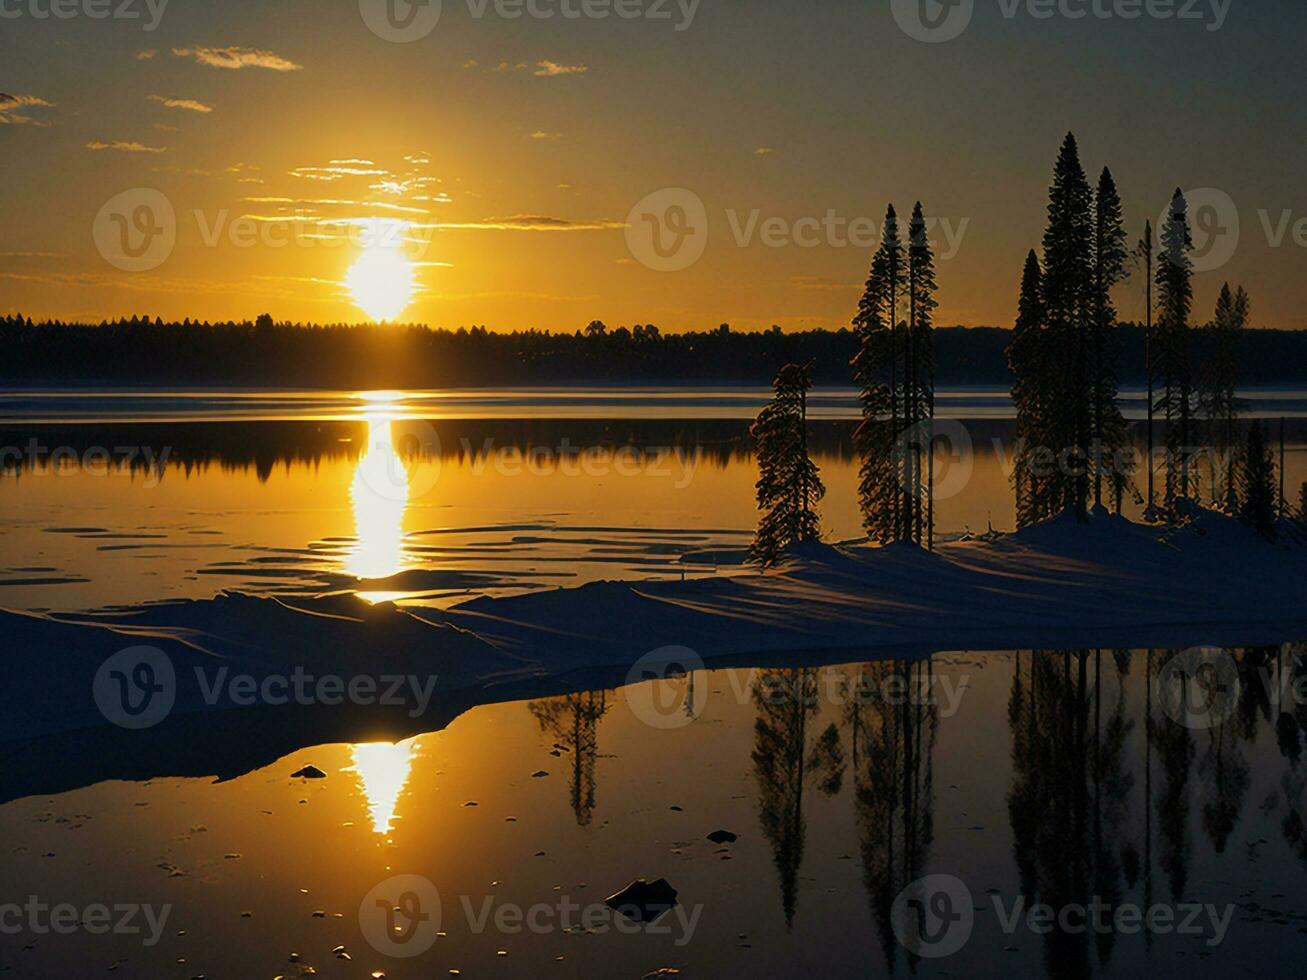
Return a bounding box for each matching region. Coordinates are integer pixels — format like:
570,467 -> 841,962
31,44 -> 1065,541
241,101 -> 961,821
0,645 -> 1307,980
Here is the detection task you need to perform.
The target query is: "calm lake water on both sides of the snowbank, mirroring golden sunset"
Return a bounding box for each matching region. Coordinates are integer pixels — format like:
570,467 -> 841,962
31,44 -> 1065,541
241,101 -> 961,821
0,389 -> 1307,980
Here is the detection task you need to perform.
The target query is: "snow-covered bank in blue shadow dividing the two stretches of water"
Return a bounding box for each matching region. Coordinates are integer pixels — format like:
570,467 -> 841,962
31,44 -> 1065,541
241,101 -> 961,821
0,511 -> 1307,794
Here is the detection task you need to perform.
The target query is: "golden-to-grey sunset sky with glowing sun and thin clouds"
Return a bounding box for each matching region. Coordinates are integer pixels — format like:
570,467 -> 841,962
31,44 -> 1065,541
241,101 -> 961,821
0,0 -> 1307,331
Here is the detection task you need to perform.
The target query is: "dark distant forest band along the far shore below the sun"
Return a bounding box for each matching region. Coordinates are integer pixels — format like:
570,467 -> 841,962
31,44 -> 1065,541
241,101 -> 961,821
0,315 -> 1307,388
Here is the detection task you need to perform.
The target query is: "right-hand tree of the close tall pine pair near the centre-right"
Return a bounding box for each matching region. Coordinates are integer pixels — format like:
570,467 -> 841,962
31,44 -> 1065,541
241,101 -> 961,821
904,201 -> 940,549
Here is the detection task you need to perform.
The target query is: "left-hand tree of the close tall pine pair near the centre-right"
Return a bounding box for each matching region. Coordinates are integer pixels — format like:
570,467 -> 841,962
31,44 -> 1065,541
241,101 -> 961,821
852,205 -> 906,544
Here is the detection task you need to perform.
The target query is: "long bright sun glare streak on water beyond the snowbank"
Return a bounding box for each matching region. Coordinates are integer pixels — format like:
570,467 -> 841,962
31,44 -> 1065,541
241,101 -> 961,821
345,412 -> 409,588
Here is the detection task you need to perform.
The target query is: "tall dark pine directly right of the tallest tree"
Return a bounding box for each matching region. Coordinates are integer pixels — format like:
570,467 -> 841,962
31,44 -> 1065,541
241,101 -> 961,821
1090,167 -> 1129,514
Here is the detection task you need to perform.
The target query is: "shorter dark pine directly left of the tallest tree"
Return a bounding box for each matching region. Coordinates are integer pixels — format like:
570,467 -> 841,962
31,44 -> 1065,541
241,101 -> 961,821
1008,248 -> 1050,528
